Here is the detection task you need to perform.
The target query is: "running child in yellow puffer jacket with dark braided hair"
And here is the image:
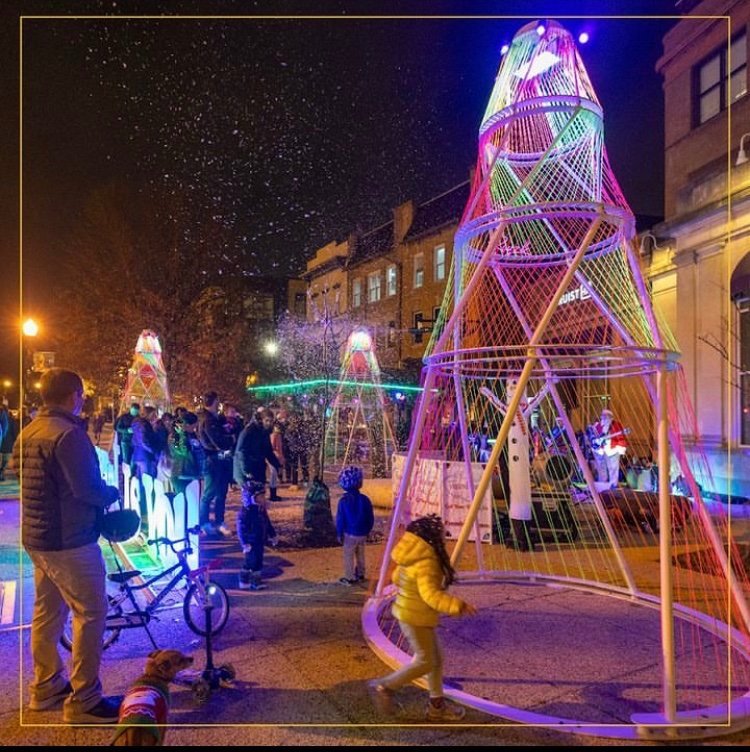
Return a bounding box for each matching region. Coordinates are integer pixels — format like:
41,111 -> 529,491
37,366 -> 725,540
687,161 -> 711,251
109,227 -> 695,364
369,514 -> 476,721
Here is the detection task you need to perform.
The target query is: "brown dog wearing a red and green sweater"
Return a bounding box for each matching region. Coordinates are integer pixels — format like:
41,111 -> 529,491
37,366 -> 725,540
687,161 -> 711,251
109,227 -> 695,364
111,650 -> 193,747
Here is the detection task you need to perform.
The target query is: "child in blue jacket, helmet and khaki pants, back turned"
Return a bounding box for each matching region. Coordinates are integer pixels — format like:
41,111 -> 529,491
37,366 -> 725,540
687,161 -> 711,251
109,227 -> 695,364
336,465 -> 375,585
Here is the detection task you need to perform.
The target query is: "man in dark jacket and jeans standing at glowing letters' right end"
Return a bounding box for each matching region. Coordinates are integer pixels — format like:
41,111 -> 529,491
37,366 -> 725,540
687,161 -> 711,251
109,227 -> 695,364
198,392 -> 234,537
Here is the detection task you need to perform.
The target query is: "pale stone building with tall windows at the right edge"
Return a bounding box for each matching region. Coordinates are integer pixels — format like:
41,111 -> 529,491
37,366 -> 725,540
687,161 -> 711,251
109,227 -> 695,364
641,0 -> 750,496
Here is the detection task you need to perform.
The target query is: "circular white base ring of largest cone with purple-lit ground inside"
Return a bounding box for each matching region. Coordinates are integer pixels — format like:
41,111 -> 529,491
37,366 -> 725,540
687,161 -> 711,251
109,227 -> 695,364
362,572 -> 750,740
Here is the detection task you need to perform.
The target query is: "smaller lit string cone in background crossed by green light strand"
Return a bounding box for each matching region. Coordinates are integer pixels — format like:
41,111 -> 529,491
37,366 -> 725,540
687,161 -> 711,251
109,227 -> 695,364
325,329 -> 395,477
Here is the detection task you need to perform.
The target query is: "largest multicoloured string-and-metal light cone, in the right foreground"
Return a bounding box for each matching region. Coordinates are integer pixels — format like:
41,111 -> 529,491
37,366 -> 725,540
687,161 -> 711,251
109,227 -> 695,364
363,22 -> 750,736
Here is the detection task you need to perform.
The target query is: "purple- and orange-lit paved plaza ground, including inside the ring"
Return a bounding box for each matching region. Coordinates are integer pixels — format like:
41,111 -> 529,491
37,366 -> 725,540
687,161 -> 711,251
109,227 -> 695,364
0,470 -> 750,746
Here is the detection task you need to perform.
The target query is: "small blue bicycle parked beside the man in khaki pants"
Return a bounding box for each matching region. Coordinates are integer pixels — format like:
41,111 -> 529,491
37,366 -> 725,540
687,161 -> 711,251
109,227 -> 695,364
60,526 -> 229,650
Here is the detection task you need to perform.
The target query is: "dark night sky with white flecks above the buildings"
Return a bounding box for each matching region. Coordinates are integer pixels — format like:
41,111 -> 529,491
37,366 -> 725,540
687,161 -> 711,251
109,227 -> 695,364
0,0 -> 676,377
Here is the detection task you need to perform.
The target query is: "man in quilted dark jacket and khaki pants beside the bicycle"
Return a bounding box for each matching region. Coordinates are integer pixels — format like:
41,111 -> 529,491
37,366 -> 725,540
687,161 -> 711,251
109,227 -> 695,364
14,368 -> 120,723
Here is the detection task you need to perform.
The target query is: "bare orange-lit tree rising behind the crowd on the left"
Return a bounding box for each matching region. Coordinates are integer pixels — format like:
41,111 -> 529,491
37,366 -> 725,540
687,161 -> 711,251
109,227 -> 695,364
56,186 -> 250,400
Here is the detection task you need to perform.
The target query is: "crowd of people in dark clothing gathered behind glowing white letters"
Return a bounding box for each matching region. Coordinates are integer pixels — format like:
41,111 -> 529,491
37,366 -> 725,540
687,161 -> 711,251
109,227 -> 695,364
114,391 -> 330,590
